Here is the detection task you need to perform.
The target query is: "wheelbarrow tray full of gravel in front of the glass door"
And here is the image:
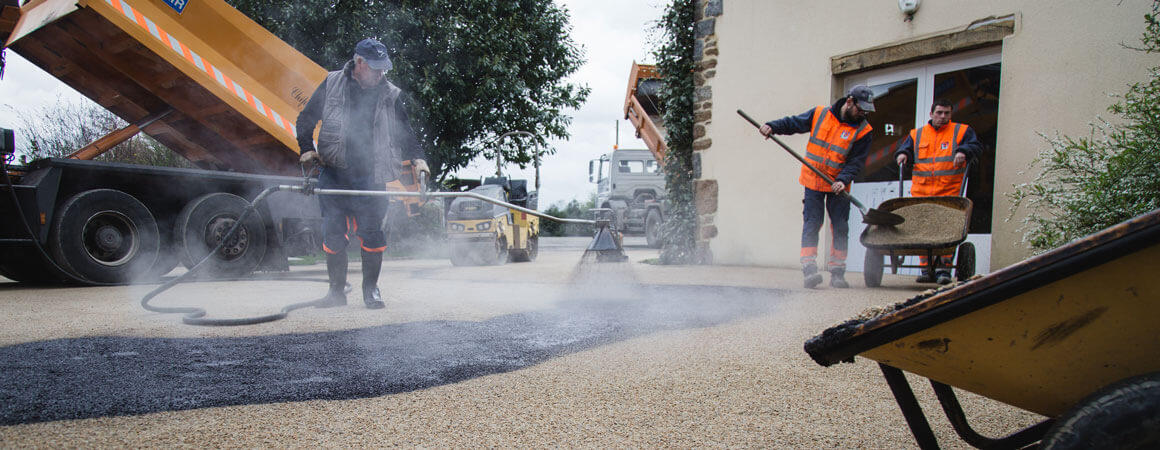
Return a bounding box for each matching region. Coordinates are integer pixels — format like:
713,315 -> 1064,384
858,196 -> 972,252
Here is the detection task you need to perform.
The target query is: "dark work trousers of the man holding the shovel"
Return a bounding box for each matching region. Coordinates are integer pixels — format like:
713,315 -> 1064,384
802,188 -> 850,270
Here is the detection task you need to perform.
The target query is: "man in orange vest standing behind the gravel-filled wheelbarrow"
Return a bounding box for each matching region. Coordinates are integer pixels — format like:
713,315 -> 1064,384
894,99 -> 983,284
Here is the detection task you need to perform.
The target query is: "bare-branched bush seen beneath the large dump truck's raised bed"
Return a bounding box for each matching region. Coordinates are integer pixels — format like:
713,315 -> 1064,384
20,97 -> 193,167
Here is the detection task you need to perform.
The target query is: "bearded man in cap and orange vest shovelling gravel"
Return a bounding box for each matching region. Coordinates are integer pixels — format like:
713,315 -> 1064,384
761,85 -> 873,288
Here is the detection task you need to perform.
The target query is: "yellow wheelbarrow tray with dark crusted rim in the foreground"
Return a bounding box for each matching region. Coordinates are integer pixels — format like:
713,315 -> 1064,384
805,210 -> 1160,417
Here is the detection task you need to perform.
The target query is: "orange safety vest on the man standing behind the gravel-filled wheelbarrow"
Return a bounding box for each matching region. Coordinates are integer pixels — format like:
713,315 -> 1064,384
911,122 -> 966,197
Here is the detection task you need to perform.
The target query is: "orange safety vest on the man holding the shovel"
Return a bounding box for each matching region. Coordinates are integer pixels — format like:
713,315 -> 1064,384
798,107 -> 873,193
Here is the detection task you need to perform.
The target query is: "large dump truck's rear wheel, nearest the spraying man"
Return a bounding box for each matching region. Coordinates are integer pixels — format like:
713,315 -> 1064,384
174,193 -> 266,276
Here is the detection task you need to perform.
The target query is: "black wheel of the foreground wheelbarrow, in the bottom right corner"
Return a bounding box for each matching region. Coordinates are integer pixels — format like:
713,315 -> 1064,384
1042,372 -> 1160,450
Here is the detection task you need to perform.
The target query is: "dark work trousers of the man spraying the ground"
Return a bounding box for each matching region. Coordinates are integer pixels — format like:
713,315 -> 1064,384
318,168 -> 386,255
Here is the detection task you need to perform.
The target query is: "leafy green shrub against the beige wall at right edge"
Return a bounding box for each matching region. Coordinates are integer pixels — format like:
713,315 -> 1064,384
1008,1 -> 1160,253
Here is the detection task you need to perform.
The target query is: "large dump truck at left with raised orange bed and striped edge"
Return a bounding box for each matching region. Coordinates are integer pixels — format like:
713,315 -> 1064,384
0,0 -> 417,284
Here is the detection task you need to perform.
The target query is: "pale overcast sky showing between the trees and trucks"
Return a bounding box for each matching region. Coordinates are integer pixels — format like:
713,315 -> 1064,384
0,0 -> 667,209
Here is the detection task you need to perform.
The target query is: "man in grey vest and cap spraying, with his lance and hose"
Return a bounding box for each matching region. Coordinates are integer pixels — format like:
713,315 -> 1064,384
142,38 -> 626,325
